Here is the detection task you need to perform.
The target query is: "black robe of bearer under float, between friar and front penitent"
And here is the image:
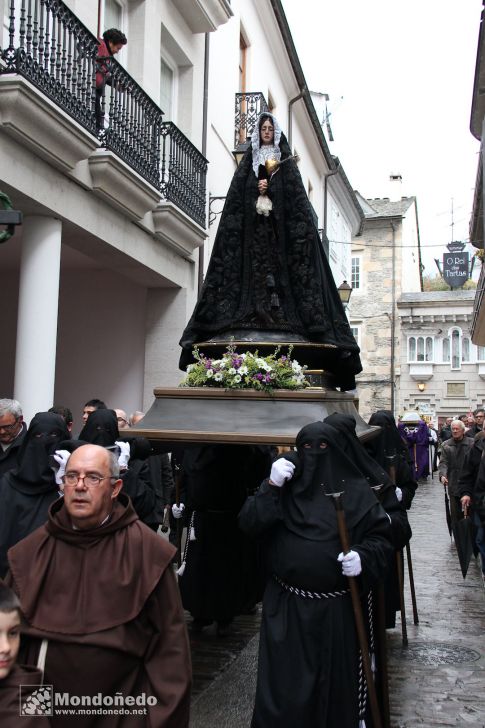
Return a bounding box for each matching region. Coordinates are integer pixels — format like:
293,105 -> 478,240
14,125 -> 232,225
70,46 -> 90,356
179,445 -> 271,624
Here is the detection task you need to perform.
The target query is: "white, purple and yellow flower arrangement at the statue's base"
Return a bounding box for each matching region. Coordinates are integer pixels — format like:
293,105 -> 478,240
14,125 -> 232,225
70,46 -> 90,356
180,346 -> 309,392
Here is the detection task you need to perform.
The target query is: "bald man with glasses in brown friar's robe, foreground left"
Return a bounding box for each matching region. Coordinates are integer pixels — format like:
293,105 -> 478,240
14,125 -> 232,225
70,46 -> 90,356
6,445 -> 191,728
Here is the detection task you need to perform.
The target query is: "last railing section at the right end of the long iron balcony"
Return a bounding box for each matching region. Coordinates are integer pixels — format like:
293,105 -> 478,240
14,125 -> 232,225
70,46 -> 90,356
160,121 -> 207,227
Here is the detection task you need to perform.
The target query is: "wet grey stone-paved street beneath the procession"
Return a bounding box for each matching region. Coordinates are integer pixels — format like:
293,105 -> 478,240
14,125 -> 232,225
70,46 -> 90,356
191,475 -> 485,728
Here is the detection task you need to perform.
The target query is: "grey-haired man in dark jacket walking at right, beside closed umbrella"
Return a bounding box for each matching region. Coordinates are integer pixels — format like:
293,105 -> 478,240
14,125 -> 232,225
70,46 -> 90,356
438,420 -> 474,523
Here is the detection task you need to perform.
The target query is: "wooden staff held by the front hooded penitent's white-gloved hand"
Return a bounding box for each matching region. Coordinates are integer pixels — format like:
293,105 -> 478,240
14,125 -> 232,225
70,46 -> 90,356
325,491 -> 382,728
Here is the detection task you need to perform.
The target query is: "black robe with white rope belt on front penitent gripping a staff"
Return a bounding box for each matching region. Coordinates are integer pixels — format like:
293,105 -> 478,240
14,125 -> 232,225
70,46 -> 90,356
239,423 -> 392,728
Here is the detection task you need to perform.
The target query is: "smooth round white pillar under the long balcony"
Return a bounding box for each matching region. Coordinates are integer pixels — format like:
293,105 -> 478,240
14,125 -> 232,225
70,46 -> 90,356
14,215 -> 62,423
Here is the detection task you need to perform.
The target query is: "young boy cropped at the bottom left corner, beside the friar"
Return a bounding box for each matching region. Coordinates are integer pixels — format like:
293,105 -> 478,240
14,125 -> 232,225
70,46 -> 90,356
0,583 -> 50,728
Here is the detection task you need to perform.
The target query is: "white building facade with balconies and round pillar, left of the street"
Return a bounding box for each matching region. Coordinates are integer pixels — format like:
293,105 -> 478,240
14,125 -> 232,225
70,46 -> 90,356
0,0 -> 362,425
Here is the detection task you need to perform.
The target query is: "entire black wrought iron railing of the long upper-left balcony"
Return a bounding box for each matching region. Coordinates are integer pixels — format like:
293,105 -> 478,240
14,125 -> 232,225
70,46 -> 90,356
0,0 -> 207,226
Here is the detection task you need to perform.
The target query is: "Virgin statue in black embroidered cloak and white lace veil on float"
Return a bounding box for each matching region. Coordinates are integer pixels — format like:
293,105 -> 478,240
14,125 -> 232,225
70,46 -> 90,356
180,113 -> 361,389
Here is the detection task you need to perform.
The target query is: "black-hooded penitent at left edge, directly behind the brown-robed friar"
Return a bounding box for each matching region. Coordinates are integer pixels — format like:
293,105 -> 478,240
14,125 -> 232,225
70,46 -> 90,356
0,412 -> 69,576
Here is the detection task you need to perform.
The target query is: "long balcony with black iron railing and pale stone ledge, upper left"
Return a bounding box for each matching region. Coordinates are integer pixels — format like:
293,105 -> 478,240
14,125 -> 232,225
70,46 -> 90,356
0,0 -> 207,232
